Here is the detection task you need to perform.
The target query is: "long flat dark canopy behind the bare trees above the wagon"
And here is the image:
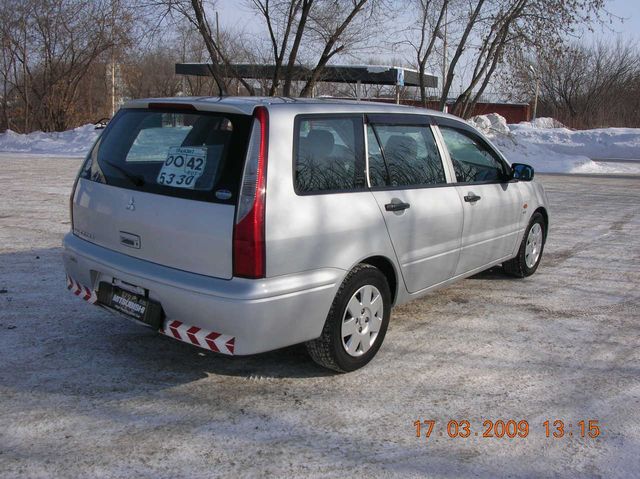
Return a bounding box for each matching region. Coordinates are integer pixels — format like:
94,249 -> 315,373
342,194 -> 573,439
176,63 -> 438,88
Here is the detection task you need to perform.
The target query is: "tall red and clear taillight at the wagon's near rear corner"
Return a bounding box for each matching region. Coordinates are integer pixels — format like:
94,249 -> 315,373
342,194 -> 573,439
233,107 -> 269,279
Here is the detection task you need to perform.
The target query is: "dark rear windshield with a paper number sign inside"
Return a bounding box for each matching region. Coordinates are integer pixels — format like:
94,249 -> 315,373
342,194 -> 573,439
81,109 -> 251,204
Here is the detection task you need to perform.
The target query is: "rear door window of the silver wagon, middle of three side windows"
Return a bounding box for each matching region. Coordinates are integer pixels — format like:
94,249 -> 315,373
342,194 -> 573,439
367,124 -> 447,186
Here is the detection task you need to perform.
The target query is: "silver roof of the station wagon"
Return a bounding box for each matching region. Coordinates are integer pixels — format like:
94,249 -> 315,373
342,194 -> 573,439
124,96 -> 463,121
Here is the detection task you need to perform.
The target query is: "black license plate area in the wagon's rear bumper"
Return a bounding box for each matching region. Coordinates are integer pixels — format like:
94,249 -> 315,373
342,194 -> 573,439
98,282 -> 163,329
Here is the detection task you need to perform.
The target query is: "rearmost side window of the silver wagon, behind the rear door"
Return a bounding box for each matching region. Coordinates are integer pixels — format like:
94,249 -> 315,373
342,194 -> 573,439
294,116 -> 366,193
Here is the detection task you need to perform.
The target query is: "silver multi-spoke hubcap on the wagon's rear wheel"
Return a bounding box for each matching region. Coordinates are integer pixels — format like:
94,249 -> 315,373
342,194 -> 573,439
342,285 -> 384,357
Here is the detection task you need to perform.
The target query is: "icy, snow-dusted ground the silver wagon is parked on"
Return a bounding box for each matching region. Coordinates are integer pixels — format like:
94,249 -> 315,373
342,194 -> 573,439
0,156 -> 640,479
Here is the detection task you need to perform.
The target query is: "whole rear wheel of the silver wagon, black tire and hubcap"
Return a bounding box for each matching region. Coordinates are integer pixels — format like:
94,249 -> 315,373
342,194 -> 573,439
306,264 -> 391,372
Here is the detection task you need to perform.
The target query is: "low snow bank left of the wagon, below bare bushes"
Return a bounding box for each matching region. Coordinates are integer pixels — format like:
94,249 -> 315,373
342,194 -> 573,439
0,124 -> 102,157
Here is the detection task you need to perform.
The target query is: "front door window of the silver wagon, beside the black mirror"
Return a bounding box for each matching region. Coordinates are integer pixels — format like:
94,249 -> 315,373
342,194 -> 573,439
440,126 -> 507,183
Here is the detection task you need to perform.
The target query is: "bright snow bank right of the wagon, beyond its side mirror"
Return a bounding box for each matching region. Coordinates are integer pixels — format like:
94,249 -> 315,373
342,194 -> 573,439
469,113 -> 640,174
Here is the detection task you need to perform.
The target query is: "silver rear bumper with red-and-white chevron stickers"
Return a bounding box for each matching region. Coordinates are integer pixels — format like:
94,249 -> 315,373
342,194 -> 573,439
63,233 -> 346,355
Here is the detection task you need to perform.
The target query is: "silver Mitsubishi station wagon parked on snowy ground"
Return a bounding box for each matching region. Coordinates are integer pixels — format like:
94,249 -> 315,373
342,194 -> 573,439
64,97 -> 549,371
